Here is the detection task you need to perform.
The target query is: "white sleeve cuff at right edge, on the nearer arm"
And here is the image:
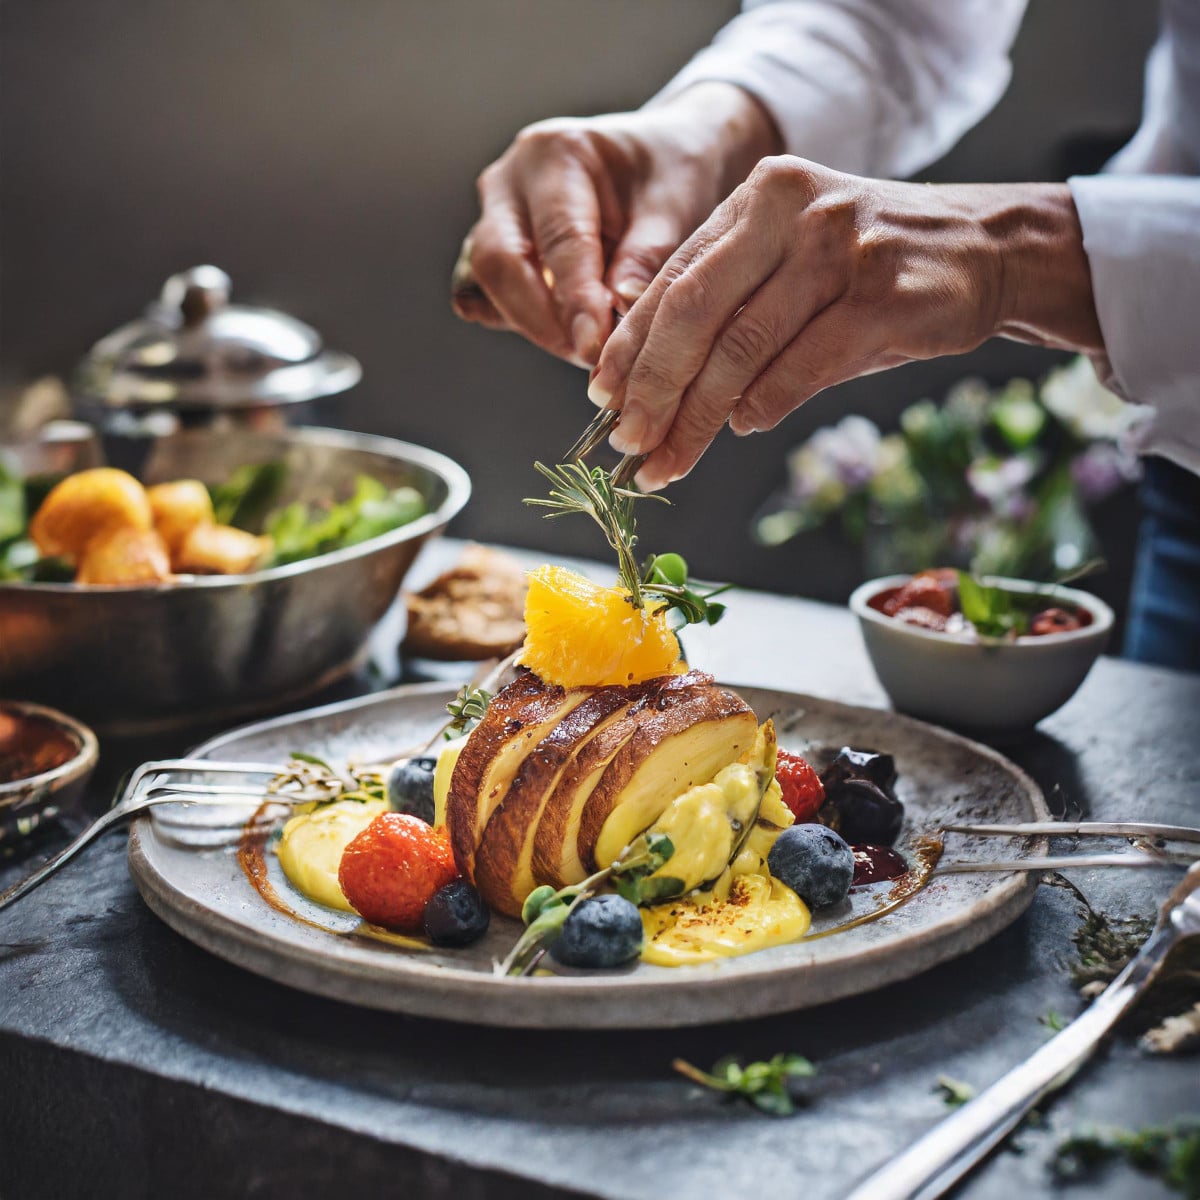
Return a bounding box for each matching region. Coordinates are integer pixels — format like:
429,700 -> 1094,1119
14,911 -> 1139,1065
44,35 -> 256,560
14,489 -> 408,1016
1069,175 -> 1200,472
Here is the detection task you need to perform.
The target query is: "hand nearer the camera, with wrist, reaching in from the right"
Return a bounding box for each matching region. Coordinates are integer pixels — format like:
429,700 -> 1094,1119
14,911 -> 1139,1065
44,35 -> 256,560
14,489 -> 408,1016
588,157 -> 1103,490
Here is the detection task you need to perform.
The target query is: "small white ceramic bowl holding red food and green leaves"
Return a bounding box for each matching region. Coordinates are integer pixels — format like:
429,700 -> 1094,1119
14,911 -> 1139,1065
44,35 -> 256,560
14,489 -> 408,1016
850,575 -> 1112,738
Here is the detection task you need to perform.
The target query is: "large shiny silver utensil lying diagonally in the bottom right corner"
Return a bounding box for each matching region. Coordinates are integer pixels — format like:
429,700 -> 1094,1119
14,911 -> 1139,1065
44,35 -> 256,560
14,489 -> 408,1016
846,862 -> 1200,1200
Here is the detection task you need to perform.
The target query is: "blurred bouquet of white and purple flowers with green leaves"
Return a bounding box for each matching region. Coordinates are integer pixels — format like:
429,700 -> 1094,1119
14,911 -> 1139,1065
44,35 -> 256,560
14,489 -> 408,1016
754,358 -> 1139,578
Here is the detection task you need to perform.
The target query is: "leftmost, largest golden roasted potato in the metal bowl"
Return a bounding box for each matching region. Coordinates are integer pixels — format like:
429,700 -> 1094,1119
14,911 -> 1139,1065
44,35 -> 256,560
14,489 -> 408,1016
29,467 -> 152,562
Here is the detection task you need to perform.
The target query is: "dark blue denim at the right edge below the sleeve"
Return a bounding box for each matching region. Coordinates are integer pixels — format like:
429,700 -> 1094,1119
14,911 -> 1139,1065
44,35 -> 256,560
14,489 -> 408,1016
1124,458 -> 1200,671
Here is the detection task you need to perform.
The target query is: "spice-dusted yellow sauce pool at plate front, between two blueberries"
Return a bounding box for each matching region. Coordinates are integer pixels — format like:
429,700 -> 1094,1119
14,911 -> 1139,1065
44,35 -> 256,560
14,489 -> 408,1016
642,875 -> 811,967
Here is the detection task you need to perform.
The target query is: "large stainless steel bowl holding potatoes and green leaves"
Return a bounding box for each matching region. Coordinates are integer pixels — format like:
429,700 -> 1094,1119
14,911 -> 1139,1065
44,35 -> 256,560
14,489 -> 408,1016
0,428 -> 470,734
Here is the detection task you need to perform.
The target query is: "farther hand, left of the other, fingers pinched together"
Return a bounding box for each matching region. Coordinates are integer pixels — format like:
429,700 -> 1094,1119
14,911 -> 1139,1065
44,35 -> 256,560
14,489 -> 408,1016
451,83 -> 779,366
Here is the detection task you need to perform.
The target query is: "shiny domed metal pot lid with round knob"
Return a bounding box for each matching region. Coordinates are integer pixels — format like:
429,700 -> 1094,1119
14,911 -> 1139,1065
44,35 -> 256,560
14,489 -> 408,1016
77,266 -> 362,409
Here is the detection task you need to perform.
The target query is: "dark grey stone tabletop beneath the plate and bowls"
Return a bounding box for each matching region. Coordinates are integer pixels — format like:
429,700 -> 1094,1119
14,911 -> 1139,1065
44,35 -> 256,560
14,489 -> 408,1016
0,542 -> 1200,1200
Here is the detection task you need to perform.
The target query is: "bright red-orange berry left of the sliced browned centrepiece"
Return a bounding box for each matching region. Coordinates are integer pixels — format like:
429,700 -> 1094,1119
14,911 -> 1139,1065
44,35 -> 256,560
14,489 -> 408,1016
337,812 -> 458,934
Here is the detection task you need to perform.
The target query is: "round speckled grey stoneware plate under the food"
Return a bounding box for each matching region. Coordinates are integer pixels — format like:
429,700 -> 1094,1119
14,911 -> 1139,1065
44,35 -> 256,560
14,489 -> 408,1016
130,684 -> 1046,1028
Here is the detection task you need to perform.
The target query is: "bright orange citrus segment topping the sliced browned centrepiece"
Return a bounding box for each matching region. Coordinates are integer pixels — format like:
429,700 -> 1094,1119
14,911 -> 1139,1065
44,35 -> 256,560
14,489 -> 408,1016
520,566 -> 688,688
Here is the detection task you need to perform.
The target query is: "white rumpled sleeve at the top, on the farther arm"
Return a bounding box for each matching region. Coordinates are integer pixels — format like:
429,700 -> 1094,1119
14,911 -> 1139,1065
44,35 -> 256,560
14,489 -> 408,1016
650,0 -> 1026,176
